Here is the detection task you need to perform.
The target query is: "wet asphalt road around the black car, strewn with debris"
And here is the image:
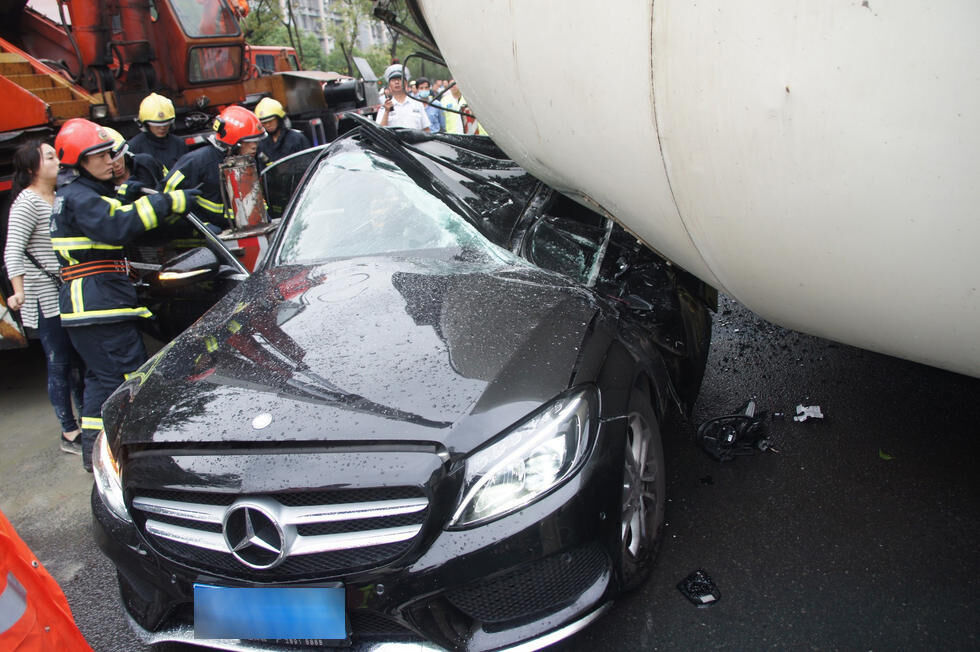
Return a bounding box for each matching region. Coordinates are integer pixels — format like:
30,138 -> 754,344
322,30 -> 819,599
0,298 -> 980,652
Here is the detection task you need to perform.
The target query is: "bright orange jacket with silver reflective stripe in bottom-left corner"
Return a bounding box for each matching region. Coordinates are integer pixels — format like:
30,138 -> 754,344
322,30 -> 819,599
0,512 -> 92,652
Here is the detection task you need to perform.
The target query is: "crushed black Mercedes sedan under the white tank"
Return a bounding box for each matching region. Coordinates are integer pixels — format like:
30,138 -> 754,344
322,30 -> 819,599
92,122 -> 716,650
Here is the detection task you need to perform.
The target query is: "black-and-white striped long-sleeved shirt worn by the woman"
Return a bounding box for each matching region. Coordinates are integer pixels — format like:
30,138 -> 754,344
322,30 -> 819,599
3,189 -> 60,328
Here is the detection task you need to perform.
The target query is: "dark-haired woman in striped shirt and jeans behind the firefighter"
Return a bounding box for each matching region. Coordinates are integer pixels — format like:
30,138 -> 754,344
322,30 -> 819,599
4,141 -> 82,455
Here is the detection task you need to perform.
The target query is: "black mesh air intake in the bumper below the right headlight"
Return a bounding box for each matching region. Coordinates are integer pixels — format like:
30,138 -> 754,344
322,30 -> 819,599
446,544 -> 607,623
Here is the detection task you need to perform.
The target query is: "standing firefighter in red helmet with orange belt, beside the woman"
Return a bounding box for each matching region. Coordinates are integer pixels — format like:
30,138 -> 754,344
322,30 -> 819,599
51,118 -> 198,471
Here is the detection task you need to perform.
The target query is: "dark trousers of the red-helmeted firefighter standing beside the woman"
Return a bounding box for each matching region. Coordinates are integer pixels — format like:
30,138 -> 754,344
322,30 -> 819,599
65,321 -> 146,471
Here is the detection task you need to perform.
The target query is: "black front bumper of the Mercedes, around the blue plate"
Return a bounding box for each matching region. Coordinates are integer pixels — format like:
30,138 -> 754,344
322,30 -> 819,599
92,421 -> 623,650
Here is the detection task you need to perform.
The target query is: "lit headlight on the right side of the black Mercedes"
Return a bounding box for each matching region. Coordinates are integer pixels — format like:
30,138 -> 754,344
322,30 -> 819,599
450,389 -> 597,527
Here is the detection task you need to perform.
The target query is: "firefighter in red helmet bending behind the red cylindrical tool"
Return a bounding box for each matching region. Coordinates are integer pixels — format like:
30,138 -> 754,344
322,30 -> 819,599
163,106 -> 266,232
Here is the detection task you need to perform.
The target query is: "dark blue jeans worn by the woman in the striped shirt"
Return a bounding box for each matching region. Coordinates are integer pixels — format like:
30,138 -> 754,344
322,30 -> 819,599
37,307 -> 84,432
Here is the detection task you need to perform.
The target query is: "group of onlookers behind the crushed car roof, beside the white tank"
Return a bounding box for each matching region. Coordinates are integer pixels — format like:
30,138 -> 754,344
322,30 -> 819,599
376,62 -> 485,134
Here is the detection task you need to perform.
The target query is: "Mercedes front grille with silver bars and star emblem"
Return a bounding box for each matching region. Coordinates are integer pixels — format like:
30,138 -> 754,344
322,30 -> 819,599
131,487 -> 428,581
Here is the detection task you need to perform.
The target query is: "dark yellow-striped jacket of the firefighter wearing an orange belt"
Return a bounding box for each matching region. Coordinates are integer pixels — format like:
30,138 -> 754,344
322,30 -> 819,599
51,176 -> 171,327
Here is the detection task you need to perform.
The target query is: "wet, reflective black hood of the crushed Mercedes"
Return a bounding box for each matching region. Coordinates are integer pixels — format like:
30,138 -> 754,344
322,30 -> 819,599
103,257 -> 598,453
